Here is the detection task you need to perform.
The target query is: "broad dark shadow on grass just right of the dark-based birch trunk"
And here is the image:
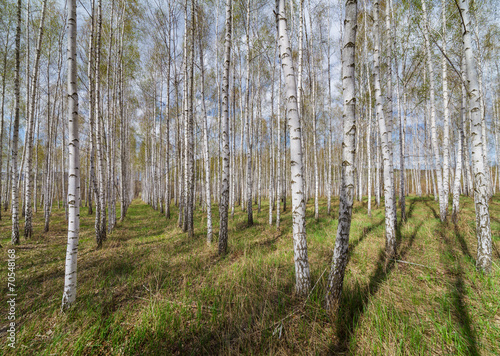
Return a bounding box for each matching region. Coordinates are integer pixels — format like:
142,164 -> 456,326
330,217 -> 423,354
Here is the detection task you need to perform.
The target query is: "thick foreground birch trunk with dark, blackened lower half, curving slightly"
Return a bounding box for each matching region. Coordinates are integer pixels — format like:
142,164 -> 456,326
326,0 -> 358,311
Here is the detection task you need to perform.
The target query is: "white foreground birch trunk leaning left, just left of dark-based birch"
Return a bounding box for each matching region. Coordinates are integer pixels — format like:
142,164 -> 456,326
276,0 -> 311,295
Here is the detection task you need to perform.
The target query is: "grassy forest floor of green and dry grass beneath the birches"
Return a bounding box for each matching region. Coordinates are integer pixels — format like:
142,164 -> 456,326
0,196 -> 500,355
